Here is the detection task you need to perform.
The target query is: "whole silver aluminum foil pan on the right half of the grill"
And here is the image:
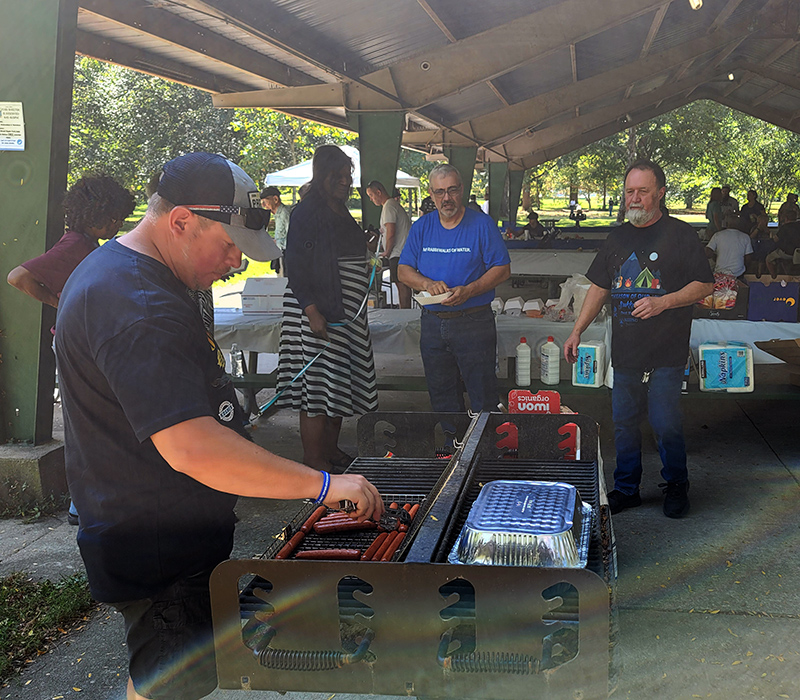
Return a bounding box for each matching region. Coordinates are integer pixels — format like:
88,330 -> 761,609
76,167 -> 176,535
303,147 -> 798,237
448,481 -> 593,568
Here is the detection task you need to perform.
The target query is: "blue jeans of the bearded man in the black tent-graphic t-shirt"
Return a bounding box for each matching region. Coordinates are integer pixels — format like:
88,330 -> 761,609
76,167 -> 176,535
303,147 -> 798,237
611,367 -> 689,495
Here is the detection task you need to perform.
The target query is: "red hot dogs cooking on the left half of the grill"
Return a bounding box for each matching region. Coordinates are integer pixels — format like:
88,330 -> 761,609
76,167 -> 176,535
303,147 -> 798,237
275,503 -> 420,561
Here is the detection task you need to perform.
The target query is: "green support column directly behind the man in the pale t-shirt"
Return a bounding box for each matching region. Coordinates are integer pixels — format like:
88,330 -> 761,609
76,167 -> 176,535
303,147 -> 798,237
348,112 -> 405,228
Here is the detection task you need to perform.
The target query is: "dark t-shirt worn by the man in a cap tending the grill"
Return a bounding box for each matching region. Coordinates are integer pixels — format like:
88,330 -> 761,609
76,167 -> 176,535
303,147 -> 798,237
56,241 -> 244,603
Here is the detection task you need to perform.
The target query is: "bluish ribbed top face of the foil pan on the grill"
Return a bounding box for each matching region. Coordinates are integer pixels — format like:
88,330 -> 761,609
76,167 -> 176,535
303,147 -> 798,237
465,480 -> 581,535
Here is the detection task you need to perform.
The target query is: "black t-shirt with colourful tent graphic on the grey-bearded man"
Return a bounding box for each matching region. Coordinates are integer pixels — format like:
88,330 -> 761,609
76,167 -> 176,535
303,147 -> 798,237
586,216 -> 714,369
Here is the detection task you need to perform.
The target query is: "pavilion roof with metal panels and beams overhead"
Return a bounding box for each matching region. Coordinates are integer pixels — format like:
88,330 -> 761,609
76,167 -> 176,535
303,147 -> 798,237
77,0 -> 800,168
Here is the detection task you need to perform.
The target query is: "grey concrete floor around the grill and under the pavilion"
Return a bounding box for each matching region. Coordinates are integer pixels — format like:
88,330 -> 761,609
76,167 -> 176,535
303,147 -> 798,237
0,356 -> 800,700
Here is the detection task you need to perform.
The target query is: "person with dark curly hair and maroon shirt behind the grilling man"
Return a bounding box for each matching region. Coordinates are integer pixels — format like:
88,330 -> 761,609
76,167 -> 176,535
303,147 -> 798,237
7,176 -> 136,308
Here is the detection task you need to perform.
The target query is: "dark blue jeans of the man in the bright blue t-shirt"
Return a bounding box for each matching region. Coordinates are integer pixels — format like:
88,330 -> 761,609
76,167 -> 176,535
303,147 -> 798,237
419,306 -> 497,413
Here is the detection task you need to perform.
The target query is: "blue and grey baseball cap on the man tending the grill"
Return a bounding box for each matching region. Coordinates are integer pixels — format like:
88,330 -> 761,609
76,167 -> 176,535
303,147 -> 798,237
156,153 -> 281,262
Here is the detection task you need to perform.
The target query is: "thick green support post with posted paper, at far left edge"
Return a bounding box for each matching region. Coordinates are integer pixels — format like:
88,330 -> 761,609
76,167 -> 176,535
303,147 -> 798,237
0,0 -> 78,444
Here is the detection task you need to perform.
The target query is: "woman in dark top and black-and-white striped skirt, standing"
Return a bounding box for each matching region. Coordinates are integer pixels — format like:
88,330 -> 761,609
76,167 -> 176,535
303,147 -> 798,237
277,146 -> 378,471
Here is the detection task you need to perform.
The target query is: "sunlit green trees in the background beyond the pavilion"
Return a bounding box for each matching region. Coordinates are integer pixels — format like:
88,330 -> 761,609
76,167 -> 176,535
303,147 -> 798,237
69,57 -> 800,209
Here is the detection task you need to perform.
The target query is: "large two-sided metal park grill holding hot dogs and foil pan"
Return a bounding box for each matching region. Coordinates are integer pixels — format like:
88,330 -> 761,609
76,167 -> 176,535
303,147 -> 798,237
211,413 -> 618,700
